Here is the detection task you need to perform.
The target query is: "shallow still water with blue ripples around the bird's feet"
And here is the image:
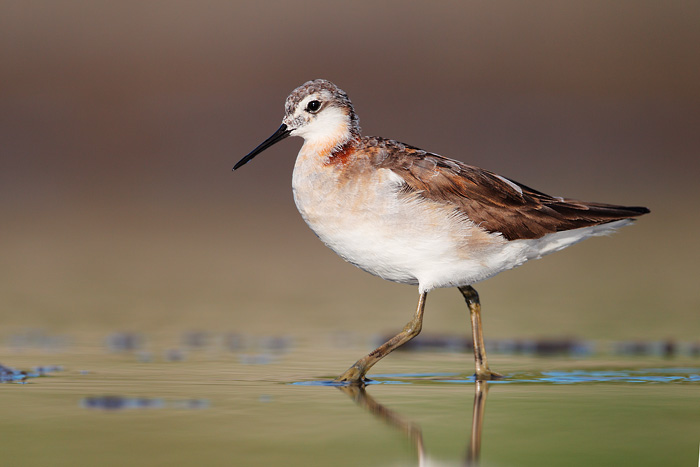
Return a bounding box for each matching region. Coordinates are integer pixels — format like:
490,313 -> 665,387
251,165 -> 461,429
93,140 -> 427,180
0,333 -> 700,466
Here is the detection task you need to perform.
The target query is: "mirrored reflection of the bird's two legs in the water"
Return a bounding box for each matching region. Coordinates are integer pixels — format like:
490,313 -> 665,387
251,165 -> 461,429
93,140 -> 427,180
338,381 -> 488,467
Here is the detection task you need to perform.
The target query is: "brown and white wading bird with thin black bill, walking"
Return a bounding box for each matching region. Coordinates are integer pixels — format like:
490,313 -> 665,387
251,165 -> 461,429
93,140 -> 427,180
233,79 -> 649,384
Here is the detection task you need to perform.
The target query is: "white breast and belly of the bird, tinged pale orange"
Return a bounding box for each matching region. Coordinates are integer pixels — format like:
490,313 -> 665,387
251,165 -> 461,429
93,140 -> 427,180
292,154 -> 527,291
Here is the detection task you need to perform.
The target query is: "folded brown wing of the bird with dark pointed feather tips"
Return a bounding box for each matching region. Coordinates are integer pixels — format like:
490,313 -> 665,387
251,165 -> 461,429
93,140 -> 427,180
375,139 -> 649,240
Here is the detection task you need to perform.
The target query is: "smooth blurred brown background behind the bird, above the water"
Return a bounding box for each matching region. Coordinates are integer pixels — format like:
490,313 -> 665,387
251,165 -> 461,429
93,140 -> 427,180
0,0 -> 700,339
